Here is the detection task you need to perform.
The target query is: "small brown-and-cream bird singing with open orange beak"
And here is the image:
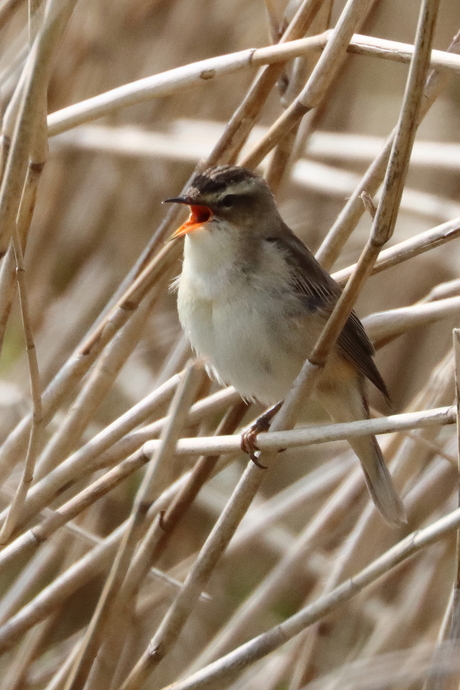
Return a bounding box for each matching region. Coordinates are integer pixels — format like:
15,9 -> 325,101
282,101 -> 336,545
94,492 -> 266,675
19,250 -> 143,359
165,165 -> 406,526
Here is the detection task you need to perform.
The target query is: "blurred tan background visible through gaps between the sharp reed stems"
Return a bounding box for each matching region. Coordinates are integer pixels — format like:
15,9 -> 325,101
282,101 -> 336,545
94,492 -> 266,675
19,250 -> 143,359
0,0 -> 460,690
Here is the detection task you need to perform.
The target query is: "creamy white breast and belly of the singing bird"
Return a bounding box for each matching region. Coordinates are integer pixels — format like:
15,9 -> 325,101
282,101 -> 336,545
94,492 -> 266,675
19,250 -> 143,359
174,230 -> 316,404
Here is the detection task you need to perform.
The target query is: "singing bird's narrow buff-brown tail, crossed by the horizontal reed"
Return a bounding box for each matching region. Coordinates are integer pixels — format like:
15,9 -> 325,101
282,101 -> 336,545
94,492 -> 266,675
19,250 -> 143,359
317,380 -> 407,525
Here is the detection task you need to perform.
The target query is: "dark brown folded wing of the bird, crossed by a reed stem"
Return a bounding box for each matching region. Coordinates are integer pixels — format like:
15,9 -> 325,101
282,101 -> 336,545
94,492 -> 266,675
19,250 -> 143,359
266,226 -> 389,400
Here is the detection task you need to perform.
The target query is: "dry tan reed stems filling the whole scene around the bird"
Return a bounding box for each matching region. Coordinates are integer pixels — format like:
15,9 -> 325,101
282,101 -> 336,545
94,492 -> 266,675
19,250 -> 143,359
0,0 -> 460,690
